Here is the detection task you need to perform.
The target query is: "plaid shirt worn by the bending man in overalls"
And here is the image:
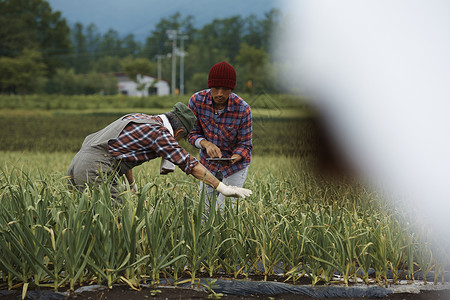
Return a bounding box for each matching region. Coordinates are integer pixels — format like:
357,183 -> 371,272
108,114 -> 198,174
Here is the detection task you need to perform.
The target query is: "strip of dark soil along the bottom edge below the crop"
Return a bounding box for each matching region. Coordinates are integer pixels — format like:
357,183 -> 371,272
0,275 -> 450,300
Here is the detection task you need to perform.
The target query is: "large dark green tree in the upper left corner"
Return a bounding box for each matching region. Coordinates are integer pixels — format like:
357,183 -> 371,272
0,0 -> 70,73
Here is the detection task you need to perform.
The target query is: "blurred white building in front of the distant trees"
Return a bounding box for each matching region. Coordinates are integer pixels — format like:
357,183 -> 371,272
116,73 -> 170,97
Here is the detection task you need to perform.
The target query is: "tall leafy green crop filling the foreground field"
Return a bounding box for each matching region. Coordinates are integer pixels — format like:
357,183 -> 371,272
0,154 -> 447,289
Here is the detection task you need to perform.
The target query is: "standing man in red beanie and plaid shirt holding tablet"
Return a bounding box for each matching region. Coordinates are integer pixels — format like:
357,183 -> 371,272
188,62 -> 253,209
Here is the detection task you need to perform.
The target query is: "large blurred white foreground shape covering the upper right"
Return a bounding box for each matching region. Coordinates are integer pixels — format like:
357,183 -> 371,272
276,0 -> 450,245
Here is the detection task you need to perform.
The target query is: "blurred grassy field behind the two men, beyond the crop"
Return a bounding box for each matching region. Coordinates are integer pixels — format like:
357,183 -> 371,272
0,95 -> 315,156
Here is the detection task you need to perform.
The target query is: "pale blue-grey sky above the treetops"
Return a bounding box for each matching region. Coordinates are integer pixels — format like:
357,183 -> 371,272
47,0 -> 281,40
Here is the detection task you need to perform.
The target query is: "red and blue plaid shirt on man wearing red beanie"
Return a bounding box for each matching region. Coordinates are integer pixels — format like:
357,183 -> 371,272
188,89 -> 253,177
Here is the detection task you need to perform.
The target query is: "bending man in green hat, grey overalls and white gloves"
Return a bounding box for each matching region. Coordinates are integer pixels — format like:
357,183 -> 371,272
67,102 -> 251,199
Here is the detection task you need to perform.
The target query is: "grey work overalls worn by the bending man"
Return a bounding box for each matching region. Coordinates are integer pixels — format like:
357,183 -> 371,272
67,117 -> 160,199
